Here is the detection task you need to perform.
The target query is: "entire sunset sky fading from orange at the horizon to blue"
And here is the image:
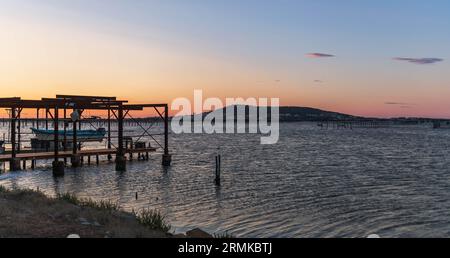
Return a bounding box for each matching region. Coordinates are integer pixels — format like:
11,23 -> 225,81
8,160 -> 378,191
0,0 -> 450,118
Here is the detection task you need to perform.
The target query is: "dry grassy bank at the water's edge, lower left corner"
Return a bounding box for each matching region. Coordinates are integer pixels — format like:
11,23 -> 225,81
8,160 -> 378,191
0,186 -> 170,238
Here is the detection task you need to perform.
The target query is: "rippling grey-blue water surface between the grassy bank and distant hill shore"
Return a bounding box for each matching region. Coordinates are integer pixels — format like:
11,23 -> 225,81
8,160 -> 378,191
0,123 -> 450,237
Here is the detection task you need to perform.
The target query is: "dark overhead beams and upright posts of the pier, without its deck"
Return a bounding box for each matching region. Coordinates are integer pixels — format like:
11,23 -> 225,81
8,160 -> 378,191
0,95 -> 171,174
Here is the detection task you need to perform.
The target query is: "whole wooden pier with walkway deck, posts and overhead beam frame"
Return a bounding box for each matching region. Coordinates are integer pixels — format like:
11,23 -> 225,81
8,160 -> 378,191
0,95 -> 171,176
